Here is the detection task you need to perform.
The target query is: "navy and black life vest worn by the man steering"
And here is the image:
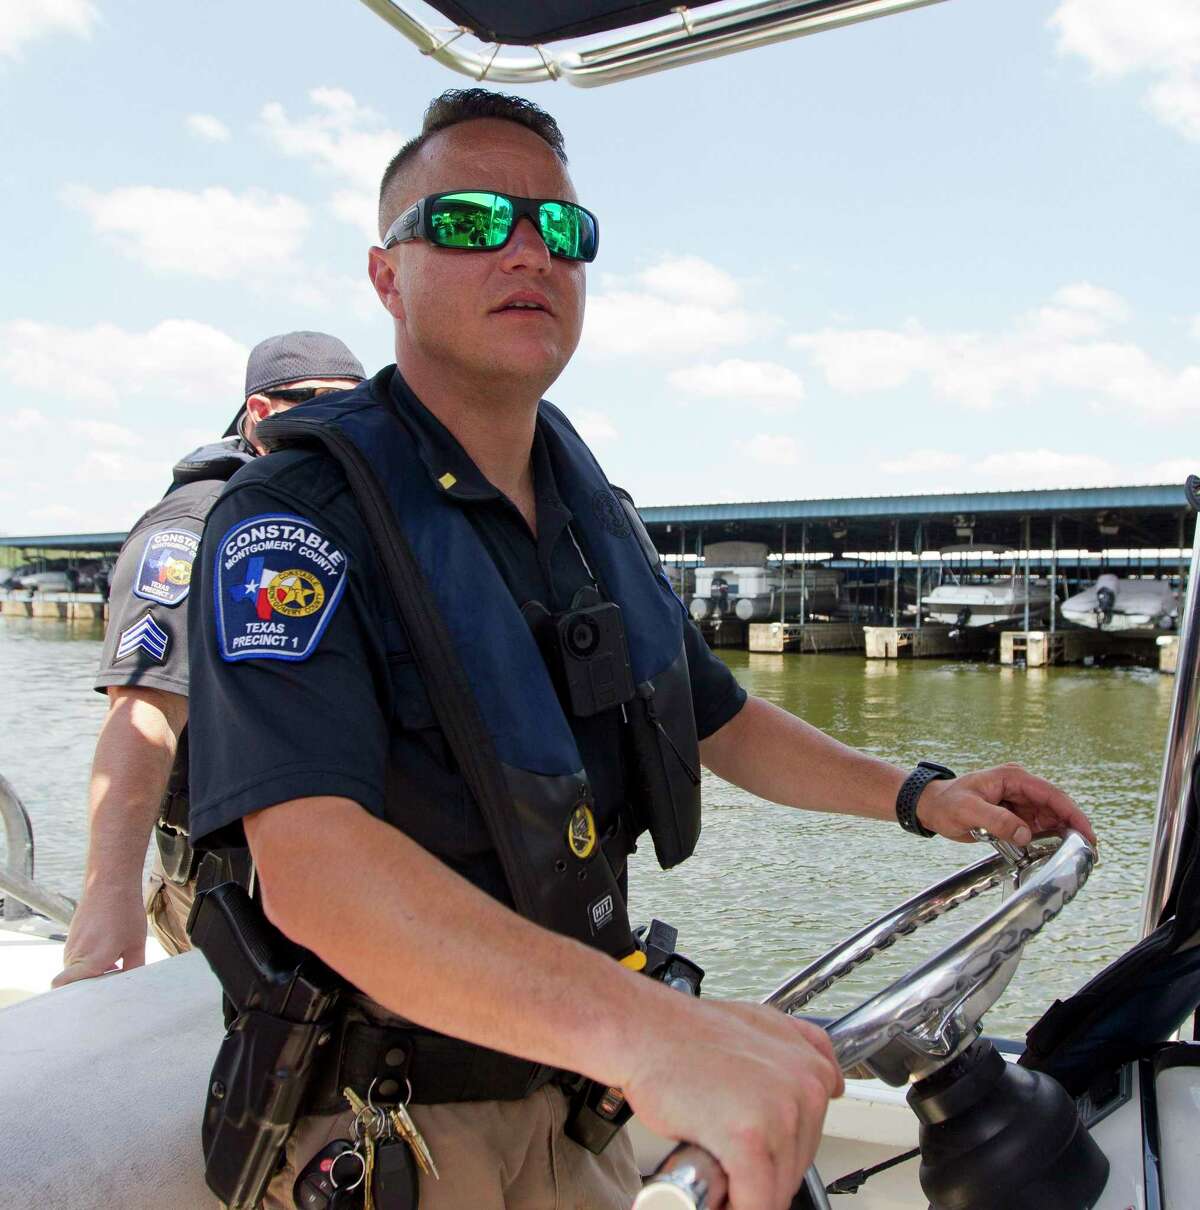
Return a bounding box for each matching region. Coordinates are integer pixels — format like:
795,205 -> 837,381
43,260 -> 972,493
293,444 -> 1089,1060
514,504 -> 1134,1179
258,367 -> 700,957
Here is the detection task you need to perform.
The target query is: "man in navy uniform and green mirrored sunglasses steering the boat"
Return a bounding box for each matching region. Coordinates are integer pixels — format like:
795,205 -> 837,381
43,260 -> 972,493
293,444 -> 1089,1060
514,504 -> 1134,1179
191,90 -> 1089,1210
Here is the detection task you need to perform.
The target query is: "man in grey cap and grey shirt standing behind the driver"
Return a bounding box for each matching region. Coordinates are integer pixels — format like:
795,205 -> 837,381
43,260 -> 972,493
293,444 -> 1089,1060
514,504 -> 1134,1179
54,332 -> 363,986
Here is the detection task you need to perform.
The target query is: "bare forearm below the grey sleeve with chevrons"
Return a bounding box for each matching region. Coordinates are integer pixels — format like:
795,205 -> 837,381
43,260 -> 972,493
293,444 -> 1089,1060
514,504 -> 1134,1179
83,686 -> 188,892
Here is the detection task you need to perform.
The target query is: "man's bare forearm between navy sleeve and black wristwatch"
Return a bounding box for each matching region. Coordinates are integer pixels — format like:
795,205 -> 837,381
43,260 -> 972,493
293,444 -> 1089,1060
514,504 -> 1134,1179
700,697 -> 906,820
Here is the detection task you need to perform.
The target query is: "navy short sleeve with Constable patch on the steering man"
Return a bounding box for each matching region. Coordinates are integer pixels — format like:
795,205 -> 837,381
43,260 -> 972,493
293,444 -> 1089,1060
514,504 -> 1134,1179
189,454 -> 387,847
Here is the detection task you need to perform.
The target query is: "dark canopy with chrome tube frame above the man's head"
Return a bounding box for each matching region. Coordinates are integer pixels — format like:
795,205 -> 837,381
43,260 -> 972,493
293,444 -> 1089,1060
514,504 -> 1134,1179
363,0 -> 940,88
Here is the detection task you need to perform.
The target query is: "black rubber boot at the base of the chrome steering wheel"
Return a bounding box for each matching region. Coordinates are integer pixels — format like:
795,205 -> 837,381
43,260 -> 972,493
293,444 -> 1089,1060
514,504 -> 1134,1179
907,1038 -> 1108,1210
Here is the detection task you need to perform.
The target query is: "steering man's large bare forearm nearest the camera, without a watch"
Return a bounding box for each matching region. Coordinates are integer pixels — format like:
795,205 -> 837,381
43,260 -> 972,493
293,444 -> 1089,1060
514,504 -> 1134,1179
246,797 -> 687,1083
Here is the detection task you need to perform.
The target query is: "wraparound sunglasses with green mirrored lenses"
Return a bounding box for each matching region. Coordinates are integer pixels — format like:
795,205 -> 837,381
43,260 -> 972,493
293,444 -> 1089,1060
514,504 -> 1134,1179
383,189 -> 600,261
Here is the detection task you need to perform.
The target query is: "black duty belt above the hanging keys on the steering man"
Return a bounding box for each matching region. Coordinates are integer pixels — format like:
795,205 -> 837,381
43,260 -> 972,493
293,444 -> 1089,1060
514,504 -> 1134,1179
304,1018 -> 569,1114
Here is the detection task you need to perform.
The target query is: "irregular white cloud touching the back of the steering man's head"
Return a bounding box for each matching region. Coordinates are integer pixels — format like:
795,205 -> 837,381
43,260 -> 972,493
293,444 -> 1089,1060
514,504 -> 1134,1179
261,88 -> 406,242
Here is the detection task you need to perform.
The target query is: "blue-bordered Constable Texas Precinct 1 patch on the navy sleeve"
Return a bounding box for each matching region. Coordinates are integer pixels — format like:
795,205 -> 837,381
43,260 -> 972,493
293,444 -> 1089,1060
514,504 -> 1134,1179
213,513 -> 350,661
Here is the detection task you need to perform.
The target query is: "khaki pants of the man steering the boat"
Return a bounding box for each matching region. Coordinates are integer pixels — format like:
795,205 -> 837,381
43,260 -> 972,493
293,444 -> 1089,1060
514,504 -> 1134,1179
263,1085 -> 641,1210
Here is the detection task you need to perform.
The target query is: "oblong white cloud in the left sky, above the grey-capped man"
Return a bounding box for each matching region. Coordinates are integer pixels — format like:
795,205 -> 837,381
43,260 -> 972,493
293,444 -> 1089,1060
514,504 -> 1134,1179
63,185 -> 308,282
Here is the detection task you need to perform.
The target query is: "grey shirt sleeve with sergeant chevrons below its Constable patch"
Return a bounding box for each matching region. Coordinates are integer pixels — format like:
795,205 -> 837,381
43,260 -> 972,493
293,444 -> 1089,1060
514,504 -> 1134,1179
94,480 -> 224,697
